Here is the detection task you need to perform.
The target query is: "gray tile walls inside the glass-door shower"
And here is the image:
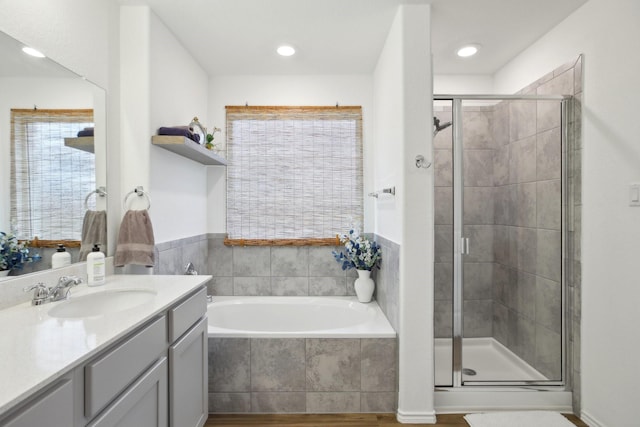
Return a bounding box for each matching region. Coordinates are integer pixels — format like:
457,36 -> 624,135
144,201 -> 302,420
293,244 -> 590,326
434,59 -> 581,384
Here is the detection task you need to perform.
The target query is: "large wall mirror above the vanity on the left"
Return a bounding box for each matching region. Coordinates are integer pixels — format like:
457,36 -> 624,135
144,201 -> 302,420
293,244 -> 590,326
0,32 -> 108,276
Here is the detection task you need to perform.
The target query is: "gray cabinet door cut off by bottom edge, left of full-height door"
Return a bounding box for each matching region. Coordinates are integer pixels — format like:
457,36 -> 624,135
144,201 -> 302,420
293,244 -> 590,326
88,357 -> 168,427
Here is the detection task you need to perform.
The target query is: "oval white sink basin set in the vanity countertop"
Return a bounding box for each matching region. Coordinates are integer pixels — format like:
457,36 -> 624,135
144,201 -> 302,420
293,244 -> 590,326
48,289 -> 157,319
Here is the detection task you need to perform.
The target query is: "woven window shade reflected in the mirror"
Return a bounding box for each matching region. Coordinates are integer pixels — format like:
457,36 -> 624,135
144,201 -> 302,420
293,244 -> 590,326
11,109 -> 96,240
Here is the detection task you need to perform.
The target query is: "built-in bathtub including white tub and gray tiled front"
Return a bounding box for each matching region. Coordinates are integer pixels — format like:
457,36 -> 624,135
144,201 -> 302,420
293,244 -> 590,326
208,296 -> 398,413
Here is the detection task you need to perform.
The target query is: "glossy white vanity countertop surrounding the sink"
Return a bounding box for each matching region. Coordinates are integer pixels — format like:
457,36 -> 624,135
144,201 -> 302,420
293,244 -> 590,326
0,275 -> 211,415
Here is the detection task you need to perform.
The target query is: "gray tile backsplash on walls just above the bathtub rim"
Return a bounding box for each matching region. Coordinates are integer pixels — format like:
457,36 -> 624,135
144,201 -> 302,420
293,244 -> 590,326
204,234 -> 400,330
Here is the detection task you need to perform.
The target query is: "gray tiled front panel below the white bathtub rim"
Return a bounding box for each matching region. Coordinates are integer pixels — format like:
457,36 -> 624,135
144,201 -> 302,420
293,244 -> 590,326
209,338 -> 397,413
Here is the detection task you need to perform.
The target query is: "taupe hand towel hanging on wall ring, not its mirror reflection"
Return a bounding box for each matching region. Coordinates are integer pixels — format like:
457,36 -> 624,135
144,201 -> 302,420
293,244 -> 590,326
114,209 -> 155,267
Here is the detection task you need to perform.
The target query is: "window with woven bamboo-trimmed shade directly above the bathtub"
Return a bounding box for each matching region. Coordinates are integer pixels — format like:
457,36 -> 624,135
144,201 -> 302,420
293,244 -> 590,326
227,107 -> 363,244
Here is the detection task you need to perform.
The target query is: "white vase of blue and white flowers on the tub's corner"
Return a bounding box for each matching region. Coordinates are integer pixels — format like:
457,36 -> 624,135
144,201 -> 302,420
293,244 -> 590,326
332,228 -> 382,302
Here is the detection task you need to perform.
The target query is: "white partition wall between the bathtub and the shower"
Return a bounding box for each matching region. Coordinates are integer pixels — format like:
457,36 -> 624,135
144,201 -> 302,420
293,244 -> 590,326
374,5 -> 436,423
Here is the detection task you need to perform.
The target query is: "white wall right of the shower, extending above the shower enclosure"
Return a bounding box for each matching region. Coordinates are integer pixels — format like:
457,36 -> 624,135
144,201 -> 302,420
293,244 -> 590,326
495,0 -> 640,427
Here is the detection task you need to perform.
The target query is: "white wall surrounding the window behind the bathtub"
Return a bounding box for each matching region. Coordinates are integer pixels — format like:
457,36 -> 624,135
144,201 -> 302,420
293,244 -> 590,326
204,75 -> 374,233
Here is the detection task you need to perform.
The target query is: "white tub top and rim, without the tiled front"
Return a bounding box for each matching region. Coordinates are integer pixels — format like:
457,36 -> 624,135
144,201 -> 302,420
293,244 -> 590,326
207,296 -> 396,338
